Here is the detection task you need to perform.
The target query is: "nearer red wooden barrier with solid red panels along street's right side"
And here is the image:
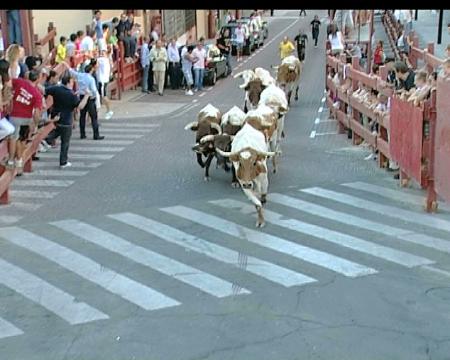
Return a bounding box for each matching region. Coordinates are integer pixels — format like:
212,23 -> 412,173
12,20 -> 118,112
326,44 -> 450,212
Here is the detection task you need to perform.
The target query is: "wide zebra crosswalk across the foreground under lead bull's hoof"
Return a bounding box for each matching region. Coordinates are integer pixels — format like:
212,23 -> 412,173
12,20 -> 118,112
0,182 -> 450,341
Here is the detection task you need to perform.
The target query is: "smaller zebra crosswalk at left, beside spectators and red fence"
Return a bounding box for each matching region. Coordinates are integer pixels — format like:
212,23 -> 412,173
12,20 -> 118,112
0,120 -> 160,226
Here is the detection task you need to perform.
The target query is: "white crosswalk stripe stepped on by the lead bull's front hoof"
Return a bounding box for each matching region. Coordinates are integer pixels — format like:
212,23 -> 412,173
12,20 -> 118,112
214,199 -> 435,268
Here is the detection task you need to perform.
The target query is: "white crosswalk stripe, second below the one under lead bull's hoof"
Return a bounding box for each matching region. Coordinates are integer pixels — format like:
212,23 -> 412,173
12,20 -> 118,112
109,213 -> 317,287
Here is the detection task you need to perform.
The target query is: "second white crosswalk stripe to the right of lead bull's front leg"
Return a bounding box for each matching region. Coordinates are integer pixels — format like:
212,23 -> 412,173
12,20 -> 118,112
299,187 -> 450,235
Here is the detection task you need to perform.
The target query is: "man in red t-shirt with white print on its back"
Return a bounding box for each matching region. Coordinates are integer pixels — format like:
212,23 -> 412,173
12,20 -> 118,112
7,70 -> 42,174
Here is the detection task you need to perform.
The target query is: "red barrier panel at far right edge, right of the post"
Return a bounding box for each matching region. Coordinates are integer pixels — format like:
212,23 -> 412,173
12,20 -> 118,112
433,78 -> 450,202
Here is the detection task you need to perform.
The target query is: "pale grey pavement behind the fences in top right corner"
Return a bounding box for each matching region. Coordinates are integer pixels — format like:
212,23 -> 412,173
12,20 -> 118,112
413,10 -> 450,58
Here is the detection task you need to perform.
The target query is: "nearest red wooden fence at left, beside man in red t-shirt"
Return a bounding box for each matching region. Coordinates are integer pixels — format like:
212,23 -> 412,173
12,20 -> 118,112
0,122 -> 55,205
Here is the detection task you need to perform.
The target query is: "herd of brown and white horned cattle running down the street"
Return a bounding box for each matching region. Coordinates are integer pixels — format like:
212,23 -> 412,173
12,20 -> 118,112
185,56 -> 302,227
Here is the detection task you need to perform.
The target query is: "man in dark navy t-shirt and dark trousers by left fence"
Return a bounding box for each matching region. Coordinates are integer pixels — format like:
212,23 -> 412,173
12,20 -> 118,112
45,71 -> 89,169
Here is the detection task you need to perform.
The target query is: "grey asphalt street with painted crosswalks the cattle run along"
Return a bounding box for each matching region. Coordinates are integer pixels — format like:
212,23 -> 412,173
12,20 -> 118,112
0,10 -> 450,360
